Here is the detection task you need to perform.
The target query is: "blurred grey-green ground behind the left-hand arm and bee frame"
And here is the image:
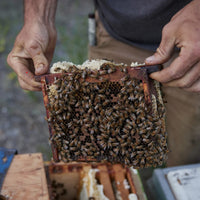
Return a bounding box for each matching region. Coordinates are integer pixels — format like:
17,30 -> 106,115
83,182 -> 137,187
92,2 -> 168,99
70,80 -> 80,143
0,0 -> 93,160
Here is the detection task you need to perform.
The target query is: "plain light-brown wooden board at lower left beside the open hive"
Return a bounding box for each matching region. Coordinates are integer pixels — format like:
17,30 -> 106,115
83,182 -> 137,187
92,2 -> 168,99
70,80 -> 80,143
1,153 -> 49,200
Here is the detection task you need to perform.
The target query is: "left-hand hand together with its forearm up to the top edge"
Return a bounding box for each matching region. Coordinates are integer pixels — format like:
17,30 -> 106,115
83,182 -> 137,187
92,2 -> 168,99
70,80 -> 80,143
7,0 -> 57,91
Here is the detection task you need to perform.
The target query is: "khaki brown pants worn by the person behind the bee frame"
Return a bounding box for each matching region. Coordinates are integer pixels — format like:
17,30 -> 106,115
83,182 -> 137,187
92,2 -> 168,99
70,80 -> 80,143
89,14 -> 200,166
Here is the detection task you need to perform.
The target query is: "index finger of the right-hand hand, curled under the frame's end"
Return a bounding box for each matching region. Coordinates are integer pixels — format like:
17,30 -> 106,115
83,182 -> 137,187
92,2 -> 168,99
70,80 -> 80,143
150,47 -> 199,83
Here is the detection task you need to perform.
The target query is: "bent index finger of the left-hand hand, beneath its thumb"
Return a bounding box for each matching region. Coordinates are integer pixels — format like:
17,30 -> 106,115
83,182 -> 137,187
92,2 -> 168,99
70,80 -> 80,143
7,52 -> 41,88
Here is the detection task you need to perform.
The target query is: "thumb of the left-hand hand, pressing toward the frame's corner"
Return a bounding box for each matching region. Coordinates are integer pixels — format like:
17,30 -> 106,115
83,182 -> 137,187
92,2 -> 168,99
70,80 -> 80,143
26,42 -> 49,75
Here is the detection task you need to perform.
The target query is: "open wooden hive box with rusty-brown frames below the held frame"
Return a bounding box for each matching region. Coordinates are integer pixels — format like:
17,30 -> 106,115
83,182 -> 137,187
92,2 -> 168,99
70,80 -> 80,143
46,163 -> 146,200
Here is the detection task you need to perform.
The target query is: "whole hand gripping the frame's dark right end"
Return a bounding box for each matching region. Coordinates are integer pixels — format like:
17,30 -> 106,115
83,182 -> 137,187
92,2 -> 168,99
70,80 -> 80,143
145,0 -> 200,92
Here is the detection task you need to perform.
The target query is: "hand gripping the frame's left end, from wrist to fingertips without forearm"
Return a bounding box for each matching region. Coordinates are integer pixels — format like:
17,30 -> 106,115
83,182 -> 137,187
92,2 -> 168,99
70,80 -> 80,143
7,20 -> 56,91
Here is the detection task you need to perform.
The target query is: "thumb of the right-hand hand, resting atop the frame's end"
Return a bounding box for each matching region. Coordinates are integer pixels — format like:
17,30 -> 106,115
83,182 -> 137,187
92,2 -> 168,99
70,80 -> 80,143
145,26 -> 175,65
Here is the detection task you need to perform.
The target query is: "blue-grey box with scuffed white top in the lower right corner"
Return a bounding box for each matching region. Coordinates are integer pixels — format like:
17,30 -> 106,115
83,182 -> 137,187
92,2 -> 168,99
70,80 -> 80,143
147,163 -> 200,200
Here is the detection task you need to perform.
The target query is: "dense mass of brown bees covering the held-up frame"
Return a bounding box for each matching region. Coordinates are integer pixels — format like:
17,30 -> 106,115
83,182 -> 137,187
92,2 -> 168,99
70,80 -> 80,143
47,63 -> 168,168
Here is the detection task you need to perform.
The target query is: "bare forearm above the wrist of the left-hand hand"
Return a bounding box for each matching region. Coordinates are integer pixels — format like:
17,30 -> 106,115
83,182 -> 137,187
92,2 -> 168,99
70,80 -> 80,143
24,0 -> 57,24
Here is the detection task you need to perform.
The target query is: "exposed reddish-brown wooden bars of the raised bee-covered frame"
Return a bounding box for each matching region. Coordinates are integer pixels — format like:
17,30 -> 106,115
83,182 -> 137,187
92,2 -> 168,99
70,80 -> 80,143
35,65 -> 162,162
